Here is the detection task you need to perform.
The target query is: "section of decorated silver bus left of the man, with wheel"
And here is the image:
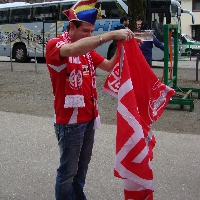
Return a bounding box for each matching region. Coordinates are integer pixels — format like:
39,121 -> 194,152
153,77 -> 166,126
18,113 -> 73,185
0,0 -> 76,62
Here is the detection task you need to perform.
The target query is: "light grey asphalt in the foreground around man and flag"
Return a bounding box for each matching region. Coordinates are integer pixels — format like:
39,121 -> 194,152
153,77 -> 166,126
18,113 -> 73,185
0,112 -> 200,200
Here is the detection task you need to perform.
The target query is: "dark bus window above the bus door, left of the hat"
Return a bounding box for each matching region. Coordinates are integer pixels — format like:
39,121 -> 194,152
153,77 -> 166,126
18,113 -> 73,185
33,5 -> 58,21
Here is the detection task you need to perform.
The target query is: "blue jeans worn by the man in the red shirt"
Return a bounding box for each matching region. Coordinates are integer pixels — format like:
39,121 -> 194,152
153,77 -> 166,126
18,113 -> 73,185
54,120 -> 95,200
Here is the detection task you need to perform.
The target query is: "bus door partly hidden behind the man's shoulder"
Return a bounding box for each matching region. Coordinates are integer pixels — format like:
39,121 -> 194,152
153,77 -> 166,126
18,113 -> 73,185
42,21 -> 58,57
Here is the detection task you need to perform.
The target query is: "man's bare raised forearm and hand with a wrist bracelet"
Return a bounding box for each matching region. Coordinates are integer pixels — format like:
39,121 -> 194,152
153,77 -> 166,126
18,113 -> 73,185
60,29 -> 137,57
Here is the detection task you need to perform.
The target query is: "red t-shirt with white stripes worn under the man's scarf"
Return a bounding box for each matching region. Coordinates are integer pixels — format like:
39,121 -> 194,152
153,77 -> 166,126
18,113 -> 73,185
46,36 -> 104,124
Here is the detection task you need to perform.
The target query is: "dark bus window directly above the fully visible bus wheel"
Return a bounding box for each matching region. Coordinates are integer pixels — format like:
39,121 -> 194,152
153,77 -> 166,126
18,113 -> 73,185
10,8 -> 31,23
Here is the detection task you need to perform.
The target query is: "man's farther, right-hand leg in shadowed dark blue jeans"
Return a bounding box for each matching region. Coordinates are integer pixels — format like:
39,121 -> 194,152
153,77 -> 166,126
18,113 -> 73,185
73,120 -> 95,200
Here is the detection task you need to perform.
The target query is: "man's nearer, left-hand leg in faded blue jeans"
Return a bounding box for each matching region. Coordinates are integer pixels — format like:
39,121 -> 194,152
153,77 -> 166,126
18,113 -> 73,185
55,123 -> 93,200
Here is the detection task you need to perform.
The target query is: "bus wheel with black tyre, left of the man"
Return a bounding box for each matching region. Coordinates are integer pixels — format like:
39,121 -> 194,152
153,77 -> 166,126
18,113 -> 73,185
14,45 -> 28,63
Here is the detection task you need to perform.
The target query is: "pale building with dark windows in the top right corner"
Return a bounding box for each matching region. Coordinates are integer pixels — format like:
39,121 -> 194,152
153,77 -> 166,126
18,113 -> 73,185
180,0 -> 200,41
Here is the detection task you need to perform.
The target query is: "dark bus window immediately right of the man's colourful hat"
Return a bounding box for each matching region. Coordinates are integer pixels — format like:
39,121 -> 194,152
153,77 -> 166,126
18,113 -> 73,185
95,1 -> 125,19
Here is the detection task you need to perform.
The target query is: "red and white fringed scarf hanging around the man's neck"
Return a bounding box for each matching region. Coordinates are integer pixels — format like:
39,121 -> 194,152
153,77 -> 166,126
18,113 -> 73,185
63,32 -> 100,126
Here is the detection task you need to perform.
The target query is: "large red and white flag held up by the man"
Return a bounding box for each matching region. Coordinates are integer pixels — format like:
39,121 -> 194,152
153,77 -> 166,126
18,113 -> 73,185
103,39 -> 174,200
